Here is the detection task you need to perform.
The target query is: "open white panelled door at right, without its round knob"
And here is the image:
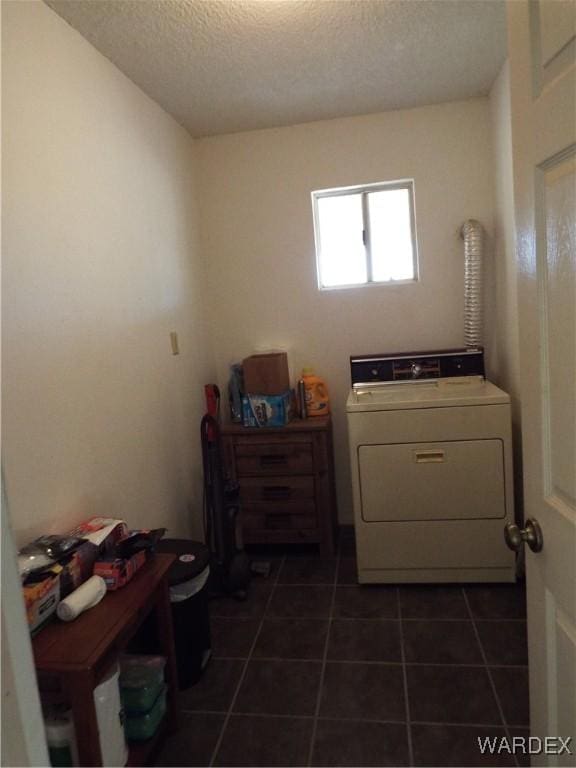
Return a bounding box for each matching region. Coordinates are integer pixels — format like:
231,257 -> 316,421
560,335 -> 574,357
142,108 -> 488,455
508,0 -> 576,765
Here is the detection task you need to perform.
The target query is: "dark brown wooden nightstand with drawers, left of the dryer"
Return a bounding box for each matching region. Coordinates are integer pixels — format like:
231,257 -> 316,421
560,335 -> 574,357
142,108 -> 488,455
221,417 -> 337,556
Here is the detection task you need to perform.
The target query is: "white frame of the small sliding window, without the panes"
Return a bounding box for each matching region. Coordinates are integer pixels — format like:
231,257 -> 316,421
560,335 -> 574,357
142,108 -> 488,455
312,179 -> 418,291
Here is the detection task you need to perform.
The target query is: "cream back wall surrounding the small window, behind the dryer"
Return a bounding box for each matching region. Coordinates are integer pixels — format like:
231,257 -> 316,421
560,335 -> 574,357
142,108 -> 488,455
197,98 -> 493,522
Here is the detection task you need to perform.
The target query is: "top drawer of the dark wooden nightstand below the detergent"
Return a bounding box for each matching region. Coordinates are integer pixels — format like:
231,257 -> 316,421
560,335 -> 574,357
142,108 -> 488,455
234,442 -> 314,476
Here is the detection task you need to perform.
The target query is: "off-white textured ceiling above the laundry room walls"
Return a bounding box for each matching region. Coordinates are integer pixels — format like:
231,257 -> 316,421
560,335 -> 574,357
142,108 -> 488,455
45,0 -> 506,136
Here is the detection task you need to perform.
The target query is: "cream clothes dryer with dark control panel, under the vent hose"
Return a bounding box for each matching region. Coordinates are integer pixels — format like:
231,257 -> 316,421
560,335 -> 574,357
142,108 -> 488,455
347,350 -> 515,583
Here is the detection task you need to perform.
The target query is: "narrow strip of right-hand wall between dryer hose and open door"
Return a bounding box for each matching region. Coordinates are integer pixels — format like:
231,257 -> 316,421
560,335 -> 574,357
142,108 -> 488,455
486,61 -> 522,515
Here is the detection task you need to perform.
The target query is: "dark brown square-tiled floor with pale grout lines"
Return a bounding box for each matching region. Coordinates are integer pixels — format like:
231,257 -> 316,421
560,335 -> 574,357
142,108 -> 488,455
156,531 -> 528,766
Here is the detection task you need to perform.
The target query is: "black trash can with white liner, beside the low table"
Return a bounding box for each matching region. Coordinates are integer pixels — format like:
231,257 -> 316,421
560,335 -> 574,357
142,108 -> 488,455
156,539 -> 211,689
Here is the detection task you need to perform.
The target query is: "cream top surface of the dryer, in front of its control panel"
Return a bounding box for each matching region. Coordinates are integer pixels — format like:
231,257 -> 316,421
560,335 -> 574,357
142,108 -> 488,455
346,376 -> 510,413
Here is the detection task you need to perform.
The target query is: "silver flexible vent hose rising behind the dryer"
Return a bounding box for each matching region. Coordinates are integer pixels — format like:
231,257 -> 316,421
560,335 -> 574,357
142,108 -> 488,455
461,219 -> 484,349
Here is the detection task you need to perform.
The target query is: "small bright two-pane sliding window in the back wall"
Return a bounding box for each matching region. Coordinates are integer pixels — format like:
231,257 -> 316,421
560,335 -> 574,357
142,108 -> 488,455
312,181 -> 417,289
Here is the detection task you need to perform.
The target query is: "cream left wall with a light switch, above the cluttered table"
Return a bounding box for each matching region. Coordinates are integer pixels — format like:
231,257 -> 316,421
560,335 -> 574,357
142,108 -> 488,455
2,0 -> 213,544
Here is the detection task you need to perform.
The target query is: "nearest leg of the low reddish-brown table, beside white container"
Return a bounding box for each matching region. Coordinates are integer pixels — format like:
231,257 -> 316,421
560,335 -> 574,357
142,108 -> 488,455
63,670 -> 102,766
